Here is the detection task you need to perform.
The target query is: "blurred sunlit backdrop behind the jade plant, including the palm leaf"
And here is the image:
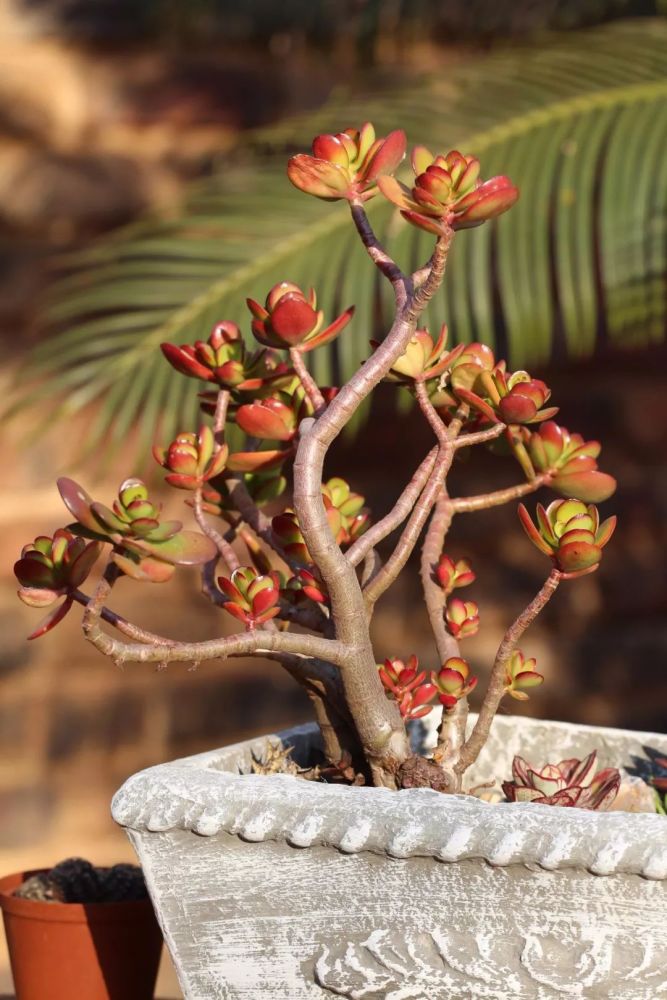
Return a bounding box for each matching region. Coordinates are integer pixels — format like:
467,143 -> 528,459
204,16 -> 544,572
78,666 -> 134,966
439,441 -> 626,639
0,0 -> 667,997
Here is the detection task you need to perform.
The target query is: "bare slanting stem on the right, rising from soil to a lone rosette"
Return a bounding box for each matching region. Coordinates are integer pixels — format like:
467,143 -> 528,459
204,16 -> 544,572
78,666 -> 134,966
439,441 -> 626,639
456,569 -> 563,774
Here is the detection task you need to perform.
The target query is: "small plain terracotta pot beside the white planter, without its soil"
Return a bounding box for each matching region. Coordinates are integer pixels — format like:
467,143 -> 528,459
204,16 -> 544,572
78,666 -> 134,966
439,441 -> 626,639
0,871 -> 162,1000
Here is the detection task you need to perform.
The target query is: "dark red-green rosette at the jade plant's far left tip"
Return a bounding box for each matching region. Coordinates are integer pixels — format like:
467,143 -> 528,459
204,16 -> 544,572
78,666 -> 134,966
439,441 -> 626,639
14,528 -> 102,639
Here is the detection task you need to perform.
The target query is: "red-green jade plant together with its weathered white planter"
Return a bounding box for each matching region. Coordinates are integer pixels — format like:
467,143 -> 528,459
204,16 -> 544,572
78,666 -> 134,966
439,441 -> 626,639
16,124 -> 667,1000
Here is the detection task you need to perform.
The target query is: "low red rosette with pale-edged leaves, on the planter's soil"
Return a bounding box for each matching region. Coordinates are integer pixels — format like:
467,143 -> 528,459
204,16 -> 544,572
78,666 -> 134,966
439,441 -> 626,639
502,750 -> 621,810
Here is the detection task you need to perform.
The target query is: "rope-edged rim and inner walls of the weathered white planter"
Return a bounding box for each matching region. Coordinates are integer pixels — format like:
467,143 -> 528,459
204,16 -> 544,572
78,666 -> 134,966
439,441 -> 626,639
112,716 -> 667,880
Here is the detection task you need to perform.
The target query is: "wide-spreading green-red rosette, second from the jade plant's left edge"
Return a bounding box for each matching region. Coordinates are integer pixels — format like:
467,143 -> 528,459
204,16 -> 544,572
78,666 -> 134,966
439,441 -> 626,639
58,477 -> 217,583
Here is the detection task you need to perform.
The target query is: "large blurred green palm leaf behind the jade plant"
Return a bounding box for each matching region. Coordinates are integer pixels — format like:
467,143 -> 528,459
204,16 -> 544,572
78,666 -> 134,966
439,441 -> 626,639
10,20 -> 667,460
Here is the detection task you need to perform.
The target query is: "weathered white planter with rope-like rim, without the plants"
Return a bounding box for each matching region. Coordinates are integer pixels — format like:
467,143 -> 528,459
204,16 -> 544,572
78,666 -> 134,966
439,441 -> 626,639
113,717 -> 667,1000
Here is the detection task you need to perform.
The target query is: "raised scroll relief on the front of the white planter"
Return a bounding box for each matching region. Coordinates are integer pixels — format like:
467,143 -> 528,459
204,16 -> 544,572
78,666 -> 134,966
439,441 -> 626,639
315,924 -> 667,1000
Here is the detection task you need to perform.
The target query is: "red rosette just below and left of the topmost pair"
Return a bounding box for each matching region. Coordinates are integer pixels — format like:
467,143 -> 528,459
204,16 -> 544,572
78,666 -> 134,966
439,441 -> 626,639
246,281 -> 354,354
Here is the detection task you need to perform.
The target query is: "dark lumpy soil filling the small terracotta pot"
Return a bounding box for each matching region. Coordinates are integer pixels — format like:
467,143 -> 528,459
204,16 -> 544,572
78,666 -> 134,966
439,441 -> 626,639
14,858 -> 148,903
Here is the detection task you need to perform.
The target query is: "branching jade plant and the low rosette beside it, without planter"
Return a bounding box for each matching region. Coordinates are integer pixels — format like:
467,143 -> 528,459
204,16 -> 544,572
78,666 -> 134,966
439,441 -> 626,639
15,124 -> 618,796
